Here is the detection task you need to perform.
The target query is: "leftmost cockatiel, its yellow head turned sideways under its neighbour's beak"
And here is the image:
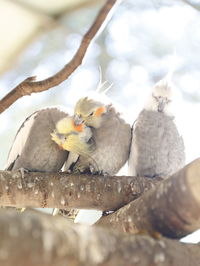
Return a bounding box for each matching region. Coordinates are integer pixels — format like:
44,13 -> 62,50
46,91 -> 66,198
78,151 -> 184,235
5,107 -> 91,172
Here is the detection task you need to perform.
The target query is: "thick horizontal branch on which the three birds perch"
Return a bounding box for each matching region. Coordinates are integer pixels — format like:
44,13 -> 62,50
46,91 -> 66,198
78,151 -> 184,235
0,171 -> 159,210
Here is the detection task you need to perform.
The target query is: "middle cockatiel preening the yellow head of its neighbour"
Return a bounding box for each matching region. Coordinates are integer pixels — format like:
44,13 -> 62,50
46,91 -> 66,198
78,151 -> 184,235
74,94 -> 131,175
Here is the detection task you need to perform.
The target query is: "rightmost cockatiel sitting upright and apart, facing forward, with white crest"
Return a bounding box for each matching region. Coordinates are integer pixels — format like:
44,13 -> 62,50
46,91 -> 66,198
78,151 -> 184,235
128,77 -> 185,177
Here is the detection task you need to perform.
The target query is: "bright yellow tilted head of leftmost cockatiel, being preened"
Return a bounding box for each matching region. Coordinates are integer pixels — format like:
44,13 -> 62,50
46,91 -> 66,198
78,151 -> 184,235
51,117 -> 92,156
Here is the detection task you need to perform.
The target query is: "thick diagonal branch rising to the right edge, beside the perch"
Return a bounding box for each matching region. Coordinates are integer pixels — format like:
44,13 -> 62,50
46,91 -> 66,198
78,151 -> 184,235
97,159 -> 200,238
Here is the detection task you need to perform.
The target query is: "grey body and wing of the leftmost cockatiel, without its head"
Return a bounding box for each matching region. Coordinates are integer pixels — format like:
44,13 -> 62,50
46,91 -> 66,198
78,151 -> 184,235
5,108 -> 68,172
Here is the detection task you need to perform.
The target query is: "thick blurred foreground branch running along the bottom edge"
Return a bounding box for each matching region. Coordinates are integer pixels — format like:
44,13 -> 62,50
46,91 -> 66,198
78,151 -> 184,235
0,210 -> 200,266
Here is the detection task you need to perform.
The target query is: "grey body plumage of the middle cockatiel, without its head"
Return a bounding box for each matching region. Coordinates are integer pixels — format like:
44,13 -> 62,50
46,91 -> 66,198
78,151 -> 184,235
73,105 -> 131,175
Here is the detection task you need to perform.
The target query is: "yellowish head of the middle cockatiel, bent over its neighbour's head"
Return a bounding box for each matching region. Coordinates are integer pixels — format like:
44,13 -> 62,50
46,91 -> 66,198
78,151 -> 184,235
74,97 -> 107,128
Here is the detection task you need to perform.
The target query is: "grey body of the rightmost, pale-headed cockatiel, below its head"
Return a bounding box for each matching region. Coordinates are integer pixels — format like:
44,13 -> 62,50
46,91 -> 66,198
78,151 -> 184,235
129,110 -> 185,177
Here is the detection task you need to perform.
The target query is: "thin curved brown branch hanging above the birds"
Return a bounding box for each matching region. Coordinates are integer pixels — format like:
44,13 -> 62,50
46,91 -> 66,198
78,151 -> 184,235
0,0 -> 119,113
